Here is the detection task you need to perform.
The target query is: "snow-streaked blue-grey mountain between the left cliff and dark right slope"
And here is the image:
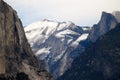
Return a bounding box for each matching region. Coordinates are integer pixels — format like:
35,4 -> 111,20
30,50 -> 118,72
25,19 -> 90,78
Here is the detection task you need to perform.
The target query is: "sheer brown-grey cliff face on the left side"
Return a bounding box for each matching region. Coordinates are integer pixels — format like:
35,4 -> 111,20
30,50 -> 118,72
0,0 -> 52,80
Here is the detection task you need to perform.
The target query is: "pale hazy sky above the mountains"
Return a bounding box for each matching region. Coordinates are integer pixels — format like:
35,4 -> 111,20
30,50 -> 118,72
4,0 -> 120,26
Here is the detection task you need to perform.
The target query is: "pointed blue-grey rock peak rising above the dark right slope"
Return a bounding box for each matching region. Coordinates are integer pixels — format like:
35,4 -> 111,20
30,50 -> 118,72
88,12 -> 118,42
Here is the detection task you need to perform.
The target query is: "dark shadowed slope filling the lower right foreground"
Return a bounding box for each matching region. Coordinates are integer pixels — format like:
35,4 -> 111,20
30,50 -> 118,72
58,24 -> 120,80
